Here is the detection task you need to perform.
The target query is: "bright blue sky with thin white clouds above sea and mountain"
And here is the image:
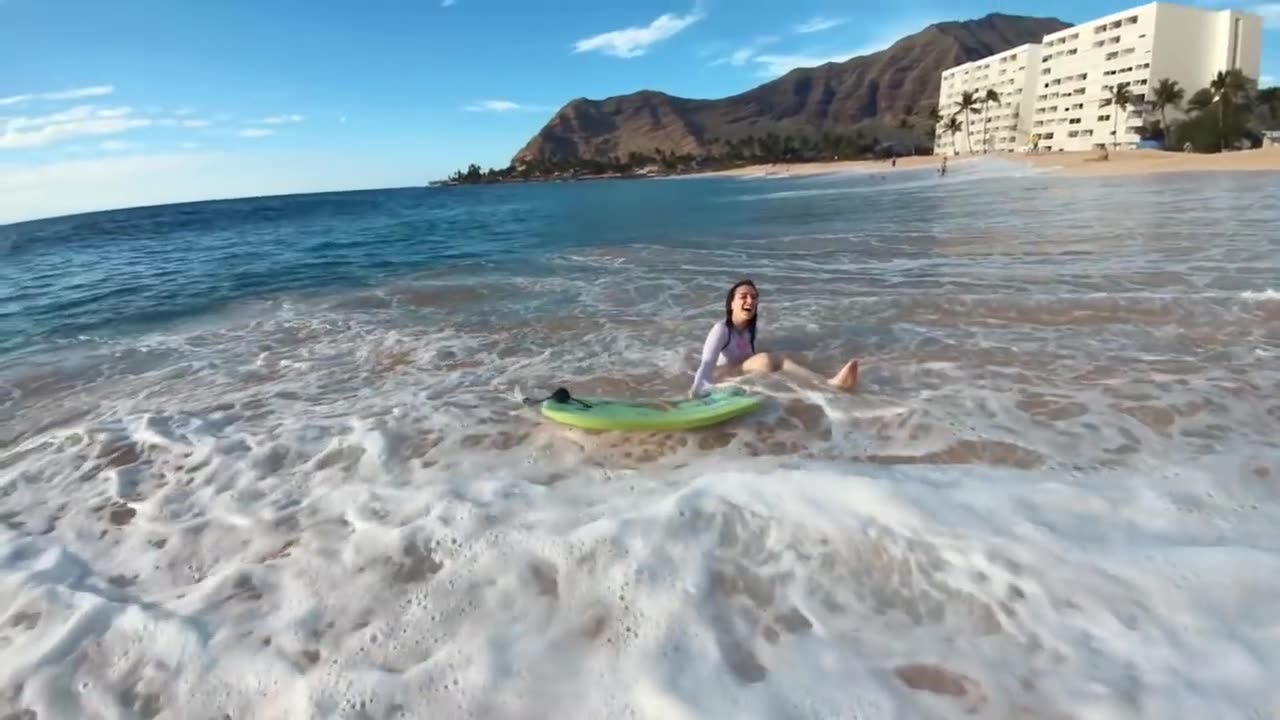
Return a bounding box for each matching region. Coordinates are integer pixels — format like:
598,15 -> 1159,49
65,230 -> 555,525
0,0 -> 1280,223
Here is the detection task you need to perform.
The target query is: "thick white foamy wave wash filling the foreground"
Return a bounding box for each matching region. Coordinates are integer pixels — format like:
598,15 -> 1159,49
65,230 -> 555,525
0,438 -> 1280,717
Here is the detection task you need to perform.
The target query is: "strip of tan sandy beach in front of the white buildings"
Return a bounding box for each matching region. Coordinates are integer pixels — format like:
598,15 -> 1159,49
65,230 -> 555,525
708,147 -> 1280,177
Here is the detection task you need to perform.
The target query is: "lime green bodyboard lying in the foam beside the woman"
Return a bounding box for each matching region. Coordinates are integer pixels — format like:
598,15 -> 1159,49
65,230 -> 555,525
543,388 -> 764,432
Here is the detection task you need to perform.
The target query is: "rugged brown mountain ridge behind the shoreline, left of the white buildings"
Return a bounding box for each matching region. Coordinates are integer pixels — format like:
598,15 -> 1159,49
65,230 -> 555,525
512,13 -> 1070,165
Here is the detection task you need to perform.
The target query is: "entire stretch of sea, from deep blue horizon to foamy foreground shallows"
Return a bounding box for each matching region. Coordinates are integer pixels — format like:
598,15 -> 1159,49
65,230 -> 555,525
0,160 -> 1280,720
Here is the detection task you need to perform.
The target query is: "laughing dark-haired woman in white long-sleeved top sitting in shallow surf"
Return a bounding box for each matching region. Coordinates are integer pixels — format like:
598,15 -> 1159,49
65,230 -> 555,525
689,279 -> 858,397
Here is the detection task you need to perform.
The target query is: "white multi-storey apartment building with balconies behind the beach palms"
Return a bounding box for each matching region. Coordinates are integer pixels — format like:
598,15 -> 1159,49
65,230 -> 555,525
934,3 -> 1262,154
